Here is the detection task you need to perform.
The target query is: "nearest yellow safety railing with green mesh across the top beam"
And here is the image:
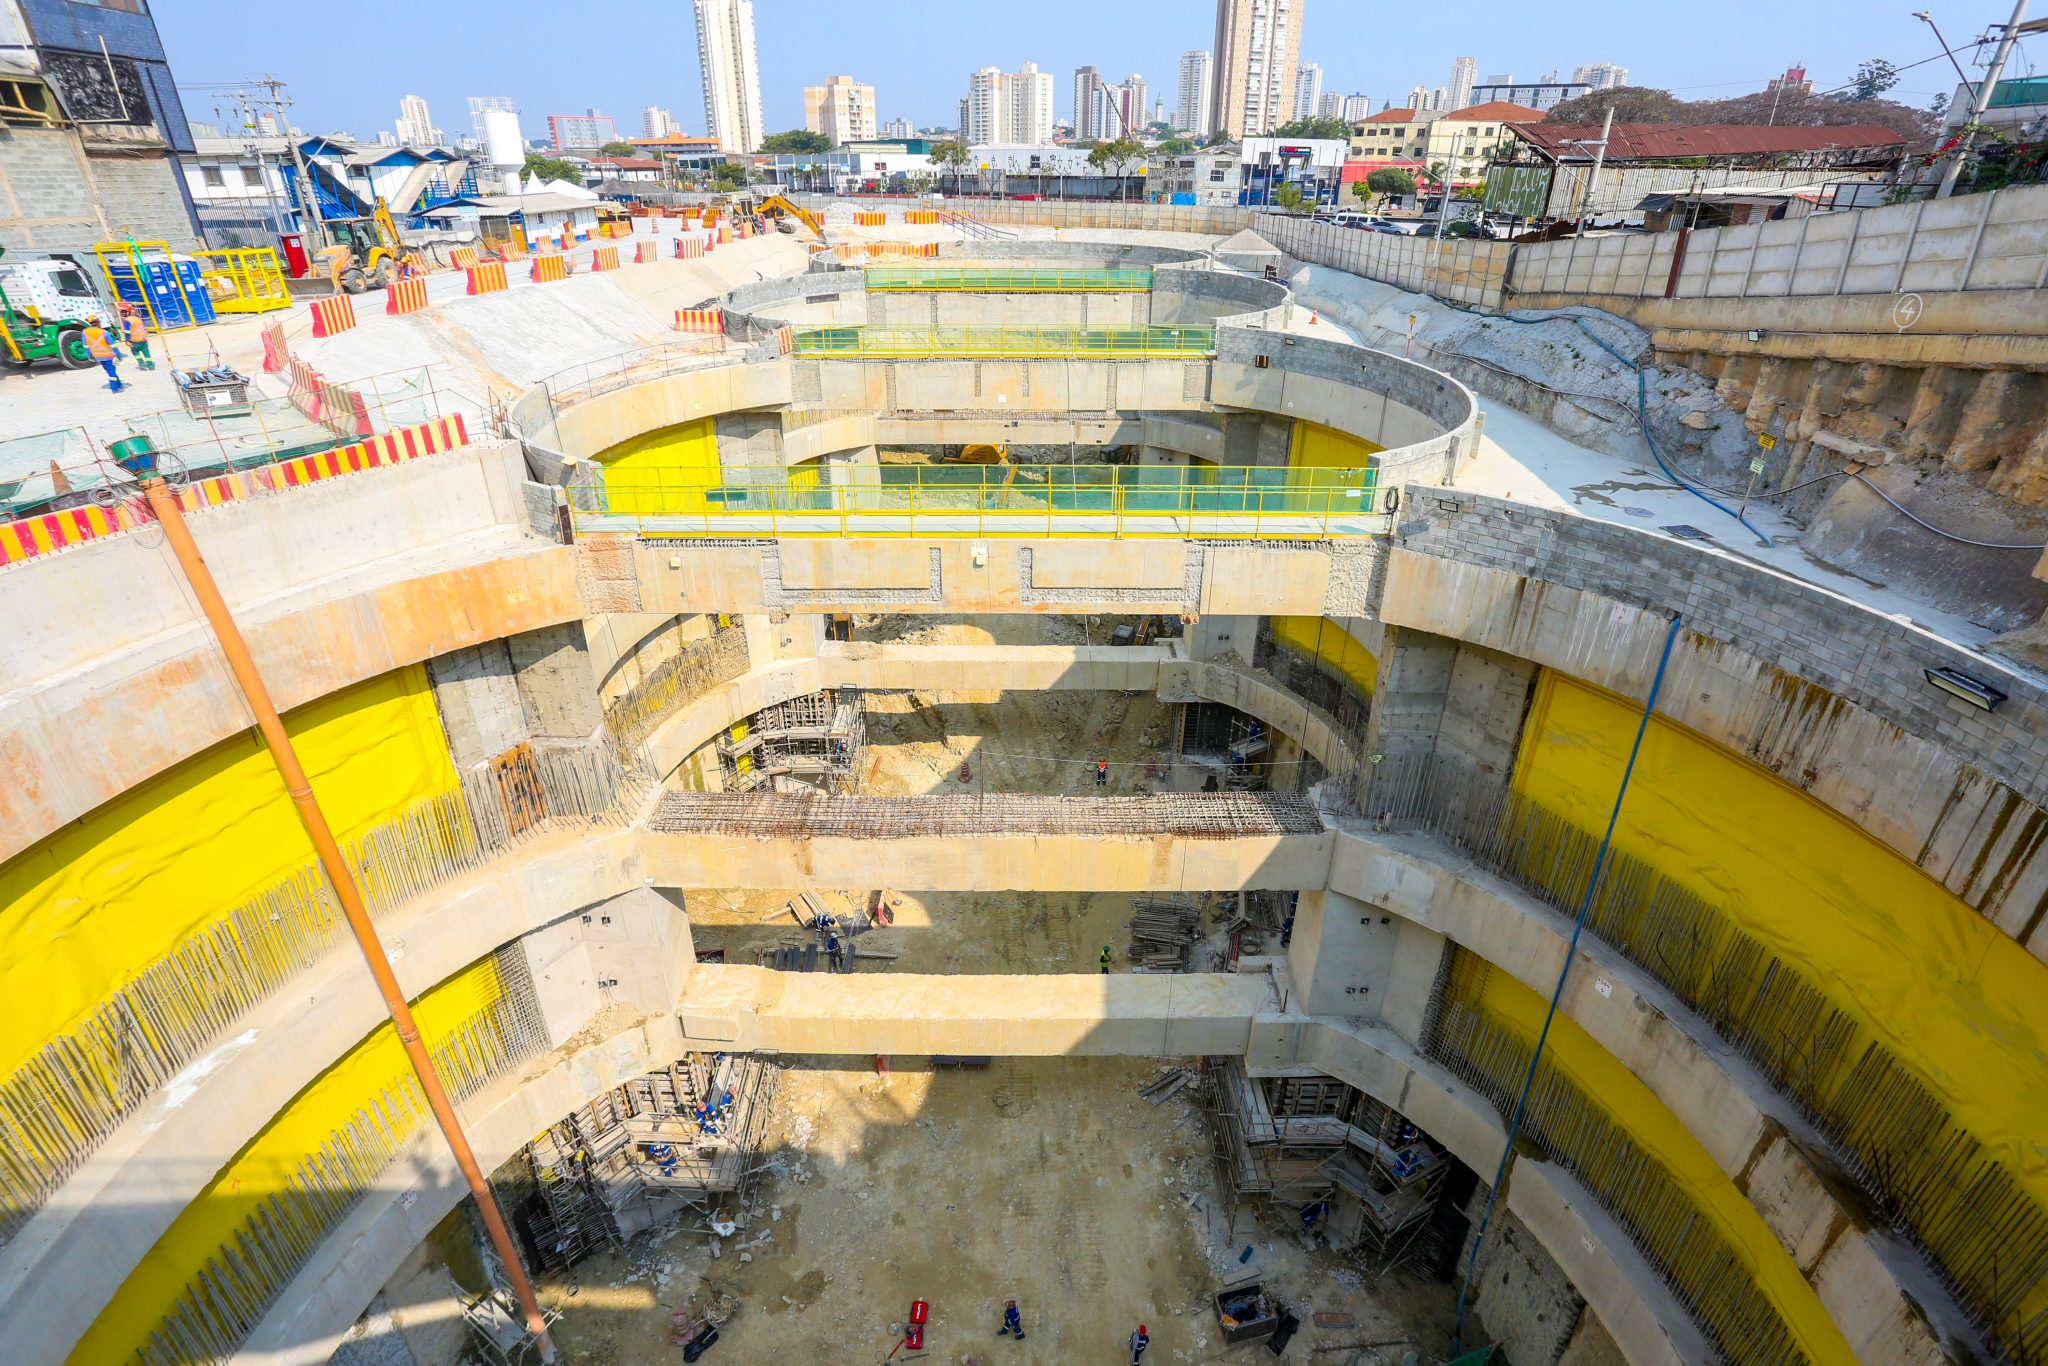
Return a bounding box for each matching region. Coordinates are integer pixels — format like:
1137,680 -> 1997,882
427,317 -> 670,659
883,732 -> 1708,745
569,463 -> 1386,539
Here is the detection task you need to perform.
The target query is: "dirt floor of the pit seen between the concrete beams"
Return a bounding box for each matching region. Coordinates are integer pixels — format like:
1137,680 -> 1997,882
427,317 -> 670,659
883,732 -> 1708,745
543,616 -> 1452,1366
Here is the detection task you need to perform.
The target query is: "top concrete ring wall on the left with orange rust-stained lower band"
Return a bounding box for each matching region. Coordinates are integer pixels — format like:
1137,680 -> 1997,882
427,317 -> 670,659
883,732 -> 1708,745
0,442 -> 584,858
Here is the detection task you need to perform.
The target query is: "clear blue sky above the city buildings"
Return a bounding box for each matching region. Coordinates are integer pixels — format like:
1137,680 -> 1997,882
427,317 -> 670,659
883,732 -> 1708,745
152,0 -> 1982,137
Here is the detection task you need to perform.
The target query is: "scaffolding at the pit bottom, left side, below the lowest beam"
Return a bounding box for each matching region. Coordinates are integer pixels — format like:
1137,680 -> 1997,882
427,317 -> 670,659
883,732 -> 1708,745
526,1053 -> 776,1270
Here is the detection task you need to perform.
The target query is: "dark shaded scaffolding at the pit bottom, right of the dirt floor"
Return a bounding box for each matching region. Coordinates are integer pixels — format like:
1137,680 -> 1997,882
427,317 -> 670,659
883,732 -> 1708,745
1200,1059 -> 1456,1276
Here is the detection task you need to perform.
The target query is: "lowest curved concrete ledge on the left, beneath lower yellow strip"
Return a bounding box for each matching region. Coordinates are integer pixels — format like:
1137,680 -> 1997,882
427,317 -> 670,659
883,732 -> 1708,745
233,1016 -> 684,1366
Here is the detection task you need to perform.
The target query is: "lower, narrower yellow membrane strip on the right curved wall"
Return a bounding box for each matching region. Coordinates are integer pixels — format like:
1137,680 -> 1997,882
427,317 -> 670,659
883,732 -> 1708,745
1458,958 -> 1855,1364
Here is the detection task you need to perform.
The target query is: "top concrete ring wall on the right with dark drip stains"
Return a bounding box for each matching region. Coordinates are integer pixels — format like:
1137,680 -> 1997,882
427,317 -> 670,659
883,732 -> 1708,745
1378,487 -> 2048,961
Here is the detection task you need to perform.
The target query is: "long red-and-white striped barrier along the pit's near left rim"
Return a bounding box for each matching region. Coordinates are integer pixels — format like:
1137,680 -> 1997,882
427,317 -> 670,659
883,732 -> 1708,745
0,414 -> 469,565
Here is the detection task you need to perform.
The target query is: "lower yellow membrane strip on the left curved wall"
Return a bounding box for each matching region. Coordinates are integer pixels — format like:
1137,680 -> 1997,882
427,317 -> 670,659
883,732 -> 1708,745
70,950 -> 506,1366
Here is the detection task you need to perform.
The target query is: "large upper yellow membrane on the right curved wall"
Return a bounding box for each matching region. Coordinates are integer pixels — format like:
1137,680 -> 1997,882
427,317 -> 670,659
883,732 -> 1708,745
1513,670 -> 2048,1253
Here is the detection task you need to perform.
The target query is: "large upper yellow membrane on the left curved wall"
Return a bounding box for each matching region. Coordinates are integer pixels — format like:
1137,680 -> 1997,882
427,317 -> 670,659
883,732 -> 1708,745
0,666 -> 457,1075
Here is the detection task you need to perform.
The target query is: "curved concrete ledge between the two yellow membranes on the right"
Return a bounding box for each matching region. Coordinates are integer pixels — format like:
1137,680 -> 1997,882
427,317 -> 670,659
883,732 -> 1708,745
1327,829 -> 1982,1366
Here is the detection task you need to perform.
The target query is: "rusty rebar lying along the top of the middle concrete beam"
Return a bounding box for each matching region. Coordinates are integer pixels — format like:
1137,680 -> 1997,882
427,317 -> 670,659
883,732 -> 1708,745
647,793 -> 1323,840
